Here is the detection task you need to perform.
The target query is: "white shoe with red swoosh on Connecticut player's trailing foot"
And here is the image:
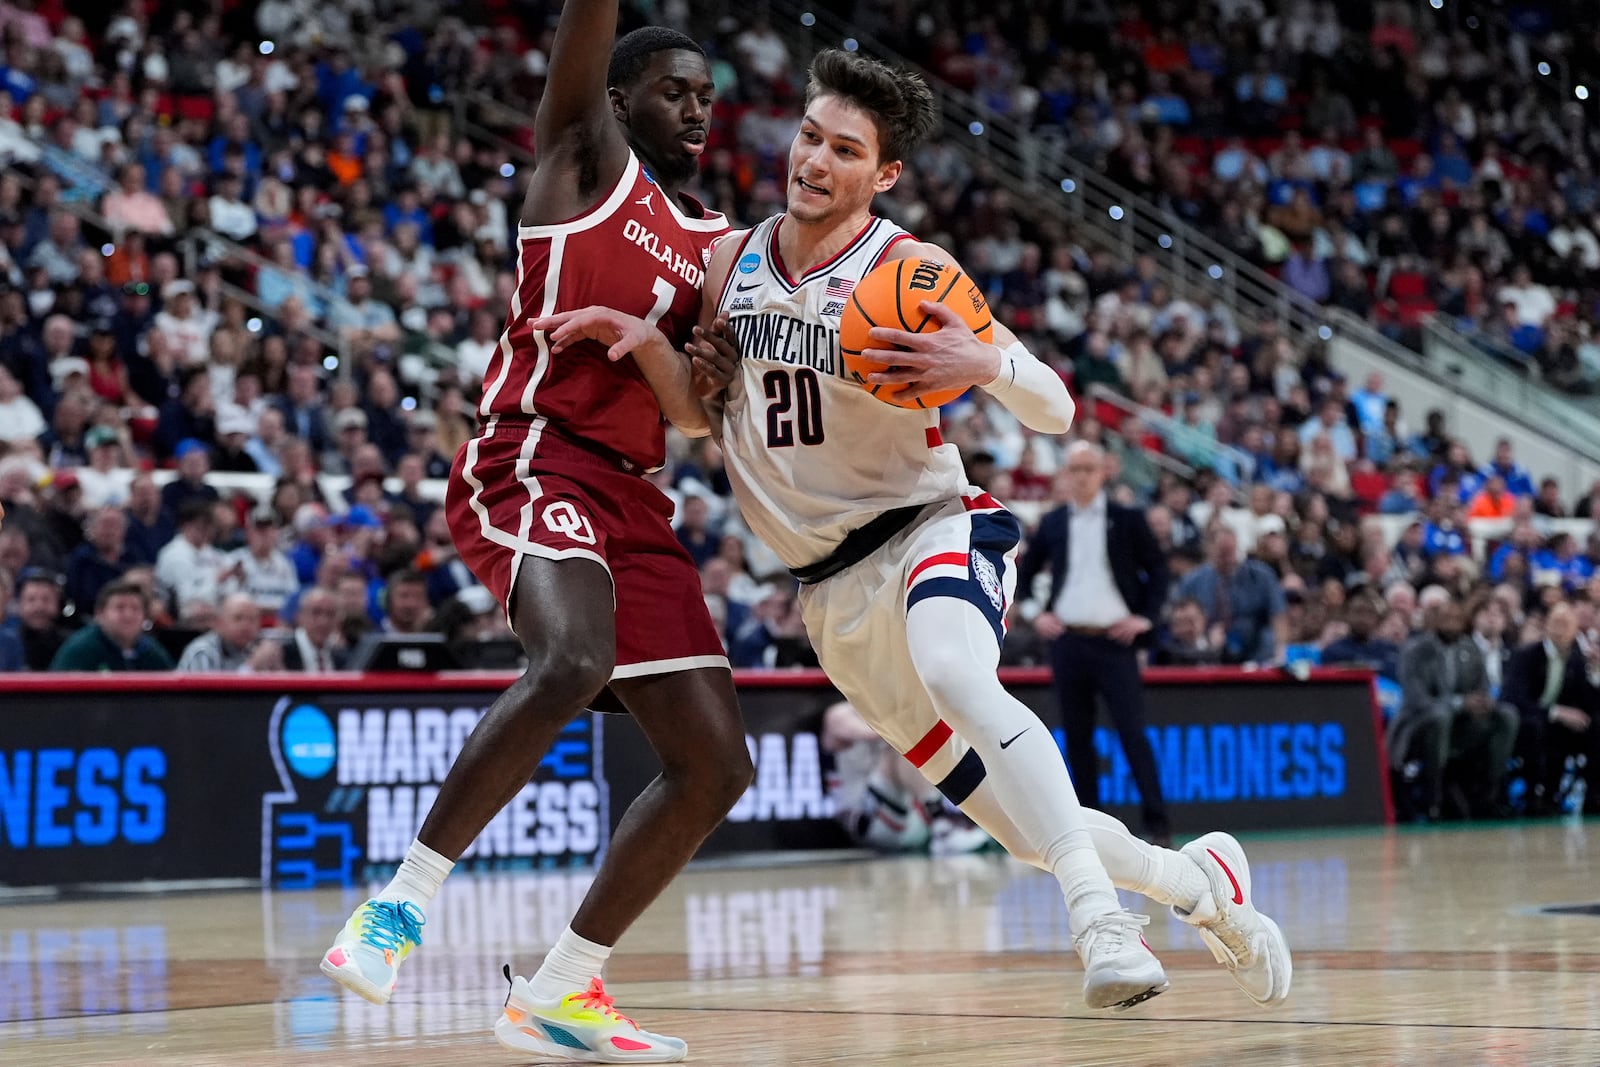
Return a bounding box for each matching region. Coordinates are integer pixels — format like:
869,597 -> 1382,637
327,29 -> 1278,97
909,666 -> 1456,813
1173,832 -> 1294,1005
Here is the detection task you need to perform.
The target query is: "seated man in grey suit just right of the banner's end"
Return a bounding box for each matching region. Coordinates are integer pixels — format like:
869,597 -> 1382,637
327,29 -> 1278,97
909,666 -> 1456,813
1389,600 -> 1517,821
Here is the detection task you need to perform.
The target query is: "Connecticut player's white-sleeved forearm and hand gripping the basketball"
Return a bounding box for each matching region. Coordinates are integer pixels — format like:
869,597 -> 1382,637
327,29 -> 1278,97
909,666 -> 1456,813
862,242 -> 1077,434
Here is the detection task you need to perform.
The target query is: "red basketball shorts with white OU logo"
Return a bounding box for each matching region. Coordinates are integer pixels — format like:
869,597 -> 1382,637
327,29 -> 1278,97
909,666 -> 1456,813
445,418 -> 728,678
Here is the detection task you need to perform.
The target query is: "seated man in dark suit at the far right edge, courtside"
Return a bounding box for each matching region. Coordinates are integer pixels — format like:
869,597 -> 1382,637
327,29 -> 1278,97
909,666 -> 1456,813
1506,603 -> 1600,814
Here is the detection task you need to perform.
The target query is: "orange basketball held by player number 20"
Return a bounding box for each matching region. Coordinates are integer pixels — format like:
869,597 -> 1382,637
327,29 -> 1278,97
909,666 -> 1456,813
838,259 -> 994,408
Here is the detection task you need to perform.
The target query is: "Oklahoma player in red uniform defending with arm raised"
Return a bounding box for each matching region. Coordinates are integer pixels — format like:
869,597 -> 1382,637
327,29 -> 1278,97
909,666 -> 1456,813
322,0 -> 754,1062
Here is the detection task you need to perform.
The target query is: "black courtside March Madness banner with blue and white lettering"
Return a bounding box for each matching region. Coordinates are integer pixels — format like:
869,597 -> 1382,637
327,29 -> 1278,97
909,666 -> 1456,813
0,672 -> 1390,886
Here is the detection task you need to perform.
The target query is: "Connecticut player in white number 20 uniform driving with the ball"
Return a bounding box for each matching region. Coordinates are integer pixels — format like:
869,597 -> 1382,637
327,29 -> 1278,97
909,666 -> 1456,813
536,51 -> 1291,1008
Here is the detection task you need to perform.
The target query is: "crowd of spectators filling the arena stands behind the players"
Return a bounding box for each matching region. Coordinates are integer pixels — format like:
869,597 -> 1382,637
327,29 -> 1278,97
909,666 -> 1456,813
0,0 -> 1600,814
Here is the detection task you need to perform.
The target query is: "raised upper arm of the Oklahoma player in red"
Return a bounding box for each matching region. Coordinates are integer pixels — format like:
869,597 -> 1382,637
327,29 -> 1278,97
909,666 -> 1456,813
522,0 -> 627,226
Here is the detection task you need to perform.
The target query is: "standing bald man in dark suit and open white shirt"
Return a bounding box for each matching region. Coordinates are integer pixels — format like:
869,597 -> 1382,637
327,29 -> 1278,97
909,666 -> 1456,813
1018,442 -> 1171,845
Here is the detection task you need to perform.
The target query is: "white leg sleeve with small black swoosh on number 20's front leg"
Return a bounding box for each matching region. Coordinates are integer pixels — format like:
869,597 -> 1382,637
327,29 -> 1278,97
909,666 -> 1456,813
906,597 -> 1122,934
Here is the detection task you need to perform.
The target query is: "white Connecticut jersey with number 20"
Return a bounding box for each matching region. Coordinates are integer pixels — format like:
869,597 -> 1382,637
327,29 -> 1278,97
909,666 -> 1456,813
717,214 -> 966,568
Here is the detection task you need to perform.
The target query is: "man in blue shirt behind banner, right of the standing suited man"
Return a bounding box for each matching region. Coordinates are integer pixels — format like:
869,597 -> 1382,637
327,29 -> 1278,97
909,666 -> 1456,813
1178,526 -> 1288,664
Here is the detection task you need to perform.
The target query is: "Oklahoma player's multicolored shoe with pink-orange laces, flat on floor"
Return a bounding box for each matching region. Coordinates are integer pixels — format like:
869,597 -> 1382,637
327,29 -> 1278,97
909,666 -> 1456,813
494,966 -> 690,1064
